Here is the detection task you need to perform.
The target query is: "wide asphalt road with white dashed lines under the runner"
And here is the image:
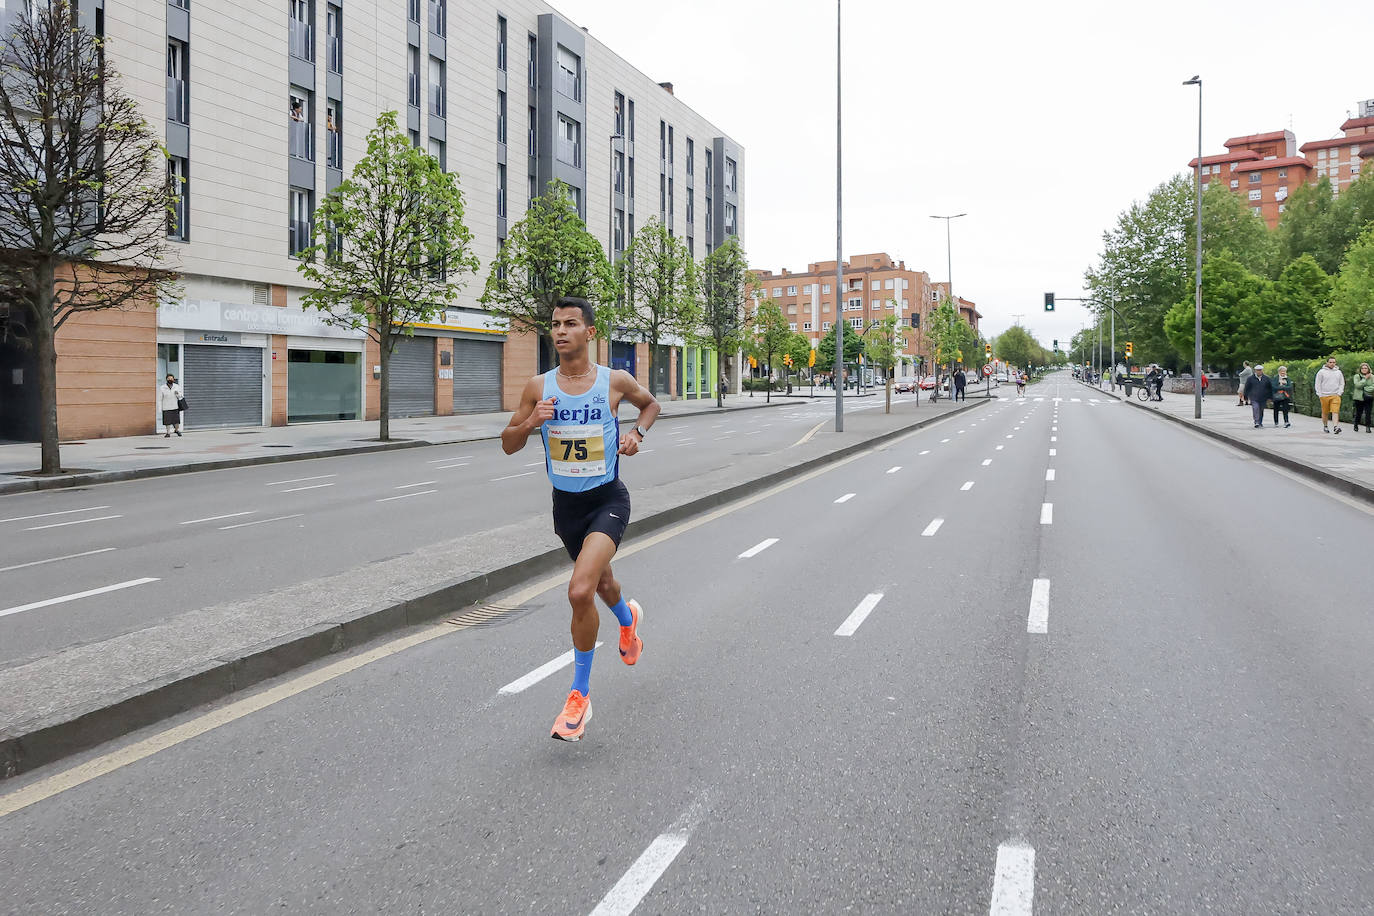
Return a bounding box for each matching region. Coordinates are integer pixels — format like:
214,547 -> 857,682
0,376 -> 1374,916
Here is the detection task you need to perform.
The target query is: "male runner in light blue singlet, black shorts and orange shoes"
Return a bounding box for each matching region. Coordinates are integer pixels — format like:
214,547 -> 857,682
502,297 -> 658,742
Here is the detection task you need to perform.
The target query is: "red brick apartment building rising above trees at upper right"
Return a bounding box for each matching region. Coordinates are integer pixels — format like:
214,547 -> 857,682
1189,99 -> 1374,228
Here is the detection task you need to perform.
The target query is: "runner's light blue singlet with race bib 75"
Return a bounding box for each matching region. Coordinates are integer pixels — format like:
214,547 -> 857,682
543,365 -> 620,493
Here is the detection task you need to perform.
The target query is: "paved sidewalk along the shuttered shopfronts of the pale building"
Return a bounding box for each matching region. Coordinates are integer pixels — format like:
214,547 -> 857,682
0,394 -> 779,494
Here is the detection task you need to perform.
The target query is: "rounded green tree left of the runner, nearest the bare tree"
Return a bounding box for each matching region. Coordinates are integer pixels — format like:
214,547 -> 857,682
297,111 -> 477,441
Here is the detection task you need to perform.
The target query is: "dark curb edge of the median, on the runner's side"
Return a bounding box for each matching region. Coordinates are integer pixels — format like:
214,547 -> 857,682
0,401 -> 987,780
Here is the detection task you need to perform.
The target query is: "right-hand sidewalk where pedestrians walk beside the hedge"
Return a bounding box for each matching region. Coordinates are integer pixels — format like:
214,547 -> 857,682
1083,385 -> 1374,503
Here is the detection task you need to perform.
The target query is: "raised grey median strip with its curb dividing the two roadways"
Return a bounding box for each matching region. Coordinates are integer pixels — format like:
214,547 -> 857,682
0,398 -> 988,779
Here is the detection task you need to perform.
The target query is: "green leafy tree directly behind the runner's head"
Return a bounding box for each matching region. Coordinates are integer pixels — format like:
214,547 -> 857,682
478,181 -> 617,367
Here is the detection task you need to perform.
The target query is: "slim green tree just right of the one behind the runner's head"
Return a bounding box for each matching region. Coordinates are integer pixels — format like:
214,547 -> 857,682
629,218 -> 701,398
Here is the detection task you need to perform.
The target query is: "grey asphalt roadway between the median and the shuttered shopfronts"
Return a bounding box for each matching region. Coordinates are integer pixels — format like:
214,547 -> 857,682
0,396 -> 912,665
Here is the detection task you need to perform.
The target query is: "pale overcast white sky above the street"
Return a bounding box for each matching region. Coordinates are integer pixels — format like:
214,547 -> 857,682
554,0 -> 1374,346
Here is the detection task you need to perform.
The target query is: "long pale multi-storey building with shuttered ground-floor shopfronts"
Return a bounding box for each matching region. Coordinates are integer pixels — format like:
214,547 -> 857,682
0,0 -> 745,438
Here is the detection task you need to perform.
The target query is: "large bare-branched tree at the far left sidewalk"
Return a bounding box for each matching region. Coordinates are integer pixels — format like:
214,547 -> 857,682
0,0 -> 180,474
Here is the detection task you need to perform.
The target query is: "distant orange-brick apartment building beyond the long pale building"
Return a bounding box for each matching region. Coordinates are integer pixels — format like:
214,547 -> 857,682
750,251 -> 982,375
